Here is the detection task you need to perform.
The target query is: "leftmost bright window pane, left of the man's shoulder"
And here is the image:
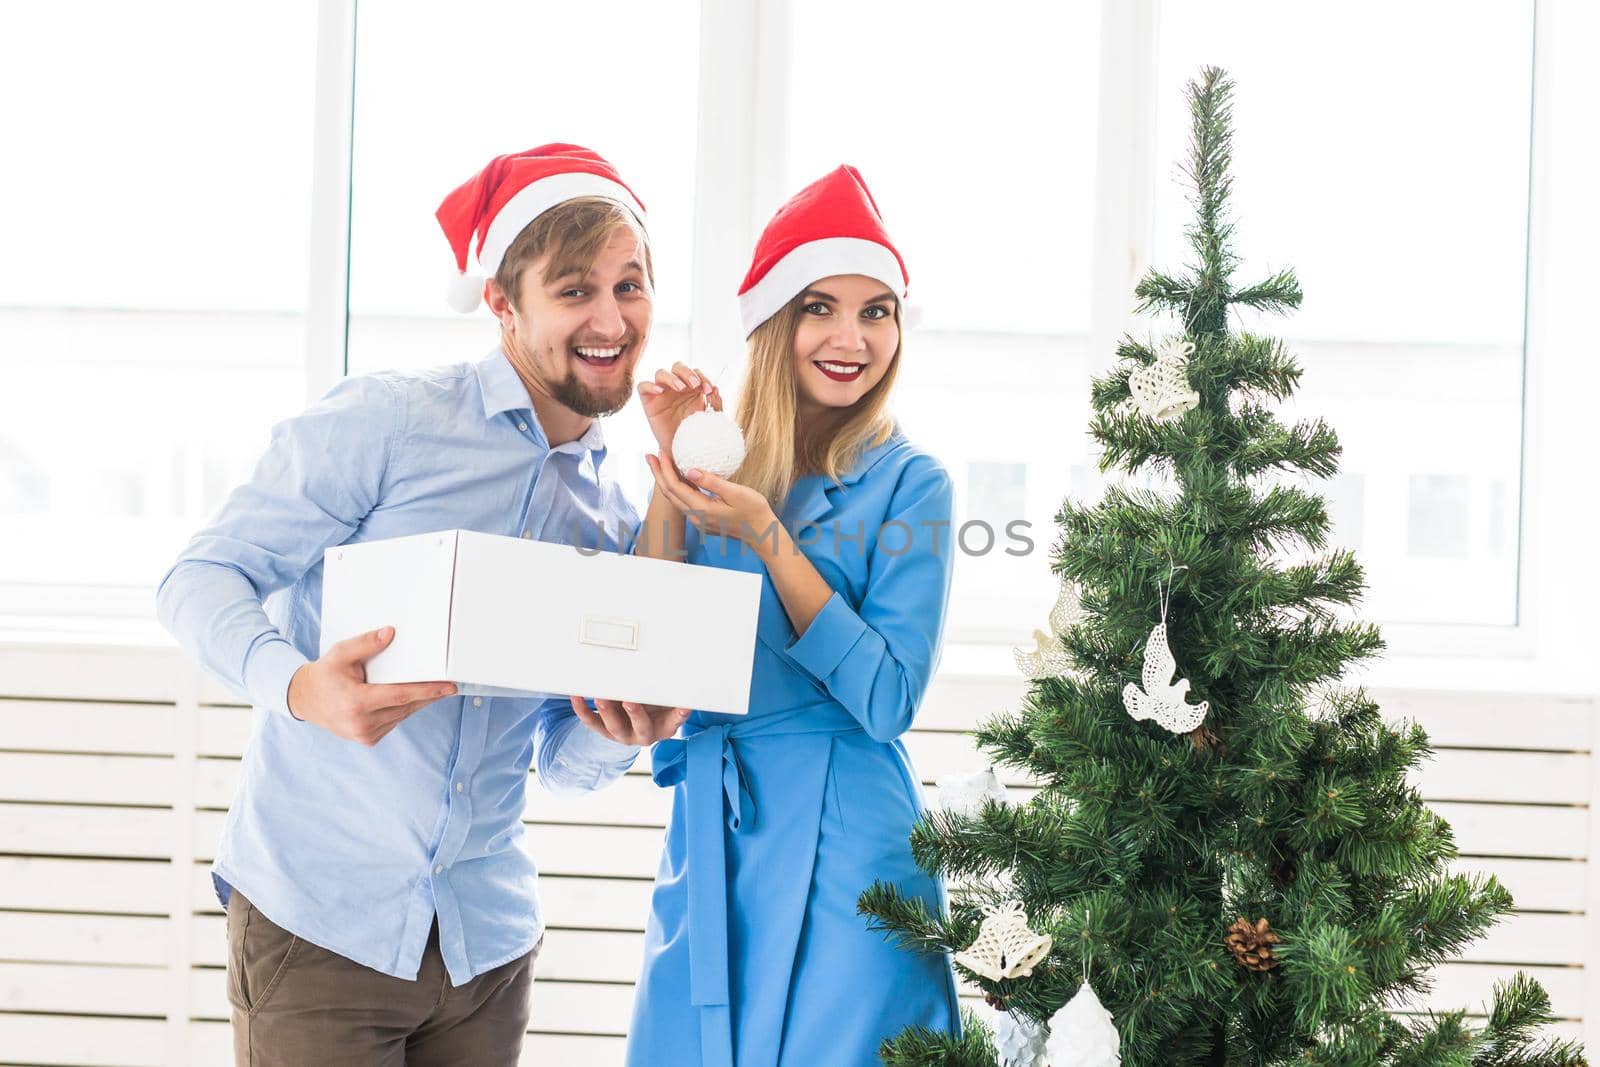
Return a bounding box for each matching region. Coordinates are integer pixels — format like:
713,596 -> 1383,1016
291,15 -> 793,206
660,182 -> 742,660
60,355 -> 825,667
0,0 -> 317,604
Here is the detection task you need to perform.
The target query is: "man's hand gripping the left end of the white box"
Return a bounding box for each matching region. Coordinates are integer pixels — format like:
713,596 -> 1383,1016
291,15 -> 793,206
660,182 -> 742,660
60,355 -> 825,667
290,625 -> 456,747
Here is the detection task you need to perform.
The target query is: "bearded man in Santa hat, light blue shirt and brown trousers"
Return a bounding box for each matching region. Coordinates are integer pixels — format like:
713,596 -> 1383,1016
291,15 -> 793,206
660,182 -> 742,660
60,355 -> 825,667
157,144 -> 686,1067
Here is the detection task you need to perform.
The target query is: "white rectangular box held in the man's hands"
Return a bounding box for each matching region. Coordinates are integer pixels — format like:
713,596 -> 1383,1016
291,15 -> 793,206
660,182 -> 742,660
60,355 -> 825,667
322,530 -> 762,715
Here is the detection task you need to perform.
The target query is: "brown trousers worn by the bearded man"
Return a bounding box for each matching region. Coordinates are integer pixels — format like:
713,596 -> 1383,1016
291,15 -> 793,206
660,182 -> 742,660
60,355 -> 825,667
227,889 -> 544,1067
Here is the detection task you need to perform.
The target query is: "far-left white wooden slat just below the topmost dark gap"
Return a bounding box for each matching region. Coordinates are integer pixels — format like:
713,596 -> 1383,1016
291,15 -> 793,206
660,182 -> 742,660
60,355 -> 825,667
0,699 -> 174,755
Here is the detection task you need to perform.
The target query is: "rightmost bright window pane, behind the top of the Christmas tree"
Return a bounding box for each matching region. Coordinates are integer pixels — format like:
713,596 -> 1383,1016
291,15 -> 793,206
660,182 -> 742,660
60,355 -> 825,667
1155,0 -> 1533,625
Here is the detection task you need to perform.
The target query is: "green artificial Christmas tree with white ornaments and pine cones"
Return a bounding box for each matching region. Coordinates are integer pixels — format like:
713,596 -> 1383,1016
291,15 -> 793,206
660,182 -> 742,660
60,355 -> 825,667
861,69 -> 1584,1067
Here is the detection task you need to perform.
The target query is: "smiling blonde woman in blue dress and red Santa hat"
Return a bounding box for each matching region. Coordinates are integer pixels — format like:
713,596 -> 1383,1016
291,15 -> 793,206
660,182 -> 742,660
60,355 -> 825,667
574,166 -> 958,1067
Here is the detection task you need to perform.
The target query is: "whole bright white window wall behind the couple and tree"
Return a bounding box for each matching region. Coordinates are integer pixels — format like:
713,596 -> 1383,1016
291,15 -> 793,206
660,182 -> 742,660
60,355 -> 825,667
0,0 -> 1548,643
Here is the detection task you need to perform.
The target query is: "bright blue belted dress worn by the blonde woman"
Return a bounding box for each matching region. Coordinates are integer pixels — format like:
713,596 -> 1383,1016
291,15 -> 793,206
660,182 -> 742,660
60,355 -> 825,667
627,432 -> 960,1067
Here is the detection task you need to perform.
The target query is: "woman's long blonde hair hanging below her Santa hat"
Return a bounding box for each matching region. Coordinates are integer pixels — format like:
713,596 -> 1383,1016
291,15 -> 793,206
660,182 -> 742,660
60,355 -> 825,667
733,293 -> 906,510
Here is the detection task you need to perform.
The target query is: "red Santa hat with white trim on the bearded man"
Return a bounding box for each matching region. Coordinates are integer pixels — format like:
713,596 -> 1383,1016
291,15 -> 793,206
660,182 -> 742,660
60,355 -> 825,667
435,144 -> 645,314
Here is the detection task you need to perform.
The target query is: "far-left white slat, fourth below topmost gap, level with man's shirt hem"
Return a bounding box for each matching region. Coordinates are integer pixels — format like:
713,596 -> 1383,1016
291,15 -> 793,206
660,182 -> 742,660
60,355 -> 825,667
0,856 -> 173,915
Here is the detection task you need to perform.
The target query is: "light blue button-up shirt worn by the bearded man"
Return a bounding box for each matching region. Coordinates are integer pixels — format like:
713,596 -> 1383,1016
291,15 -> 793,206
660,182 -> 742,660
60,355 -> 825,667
157,350 -> 638,985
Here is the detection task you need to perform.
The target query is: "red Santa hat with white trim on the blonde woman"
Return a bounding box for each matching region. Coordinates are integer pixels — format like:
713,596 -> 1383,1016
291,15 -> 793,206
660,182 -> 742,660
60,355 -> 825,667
739,166 -> 910,338
